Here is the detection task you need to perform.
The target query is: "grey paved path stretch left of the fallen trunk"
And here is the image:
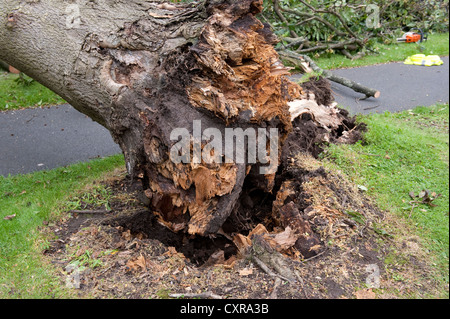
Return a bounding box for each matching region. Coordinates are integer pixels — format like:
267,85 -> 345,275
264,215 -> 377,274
0,104 -> 120,176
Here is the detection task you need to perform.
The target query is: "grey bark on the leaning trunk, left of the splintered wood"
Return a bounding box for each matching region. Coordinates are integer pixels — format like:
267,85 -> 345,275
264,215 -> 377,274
0,0 -> 206,162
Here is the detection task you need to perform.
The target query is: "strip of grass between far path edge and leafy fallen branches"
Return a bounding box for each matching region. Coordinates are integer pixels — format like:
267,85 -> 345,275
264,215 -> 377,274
312,33 -> 449,70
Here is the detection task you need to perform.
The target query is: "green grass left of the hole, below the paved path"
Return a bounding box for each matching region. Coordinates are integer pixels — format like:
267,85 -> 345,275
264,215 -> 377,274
0,155 -> 124,299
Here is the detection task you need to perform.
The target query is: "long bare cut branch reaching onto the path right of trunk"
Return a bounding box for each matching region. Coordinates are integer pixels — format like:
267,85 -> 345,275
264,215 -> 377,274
278,50 -> 381,99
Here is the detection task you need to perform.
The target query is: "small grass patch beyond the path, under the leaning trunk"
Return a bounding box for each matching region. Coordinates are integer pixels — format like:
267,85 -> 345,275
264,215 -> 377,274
0,70 -> 65,112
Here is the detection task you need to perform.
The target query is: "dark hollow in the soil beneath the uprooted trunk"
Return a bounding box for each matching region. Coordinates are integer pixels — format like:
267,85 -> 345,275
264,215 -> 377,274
105,160 -> 316,266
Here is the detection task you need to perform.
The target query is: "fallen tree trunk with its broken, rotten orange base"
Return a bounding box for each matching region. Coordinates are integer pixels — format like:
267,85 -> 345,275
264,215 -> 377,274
0,0 -> 364,262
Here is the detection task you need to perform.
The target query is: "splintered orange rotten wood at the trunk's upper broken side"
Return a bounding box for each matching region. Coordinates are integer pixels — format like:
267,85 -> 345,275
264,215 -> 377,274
187,15 -> 301,126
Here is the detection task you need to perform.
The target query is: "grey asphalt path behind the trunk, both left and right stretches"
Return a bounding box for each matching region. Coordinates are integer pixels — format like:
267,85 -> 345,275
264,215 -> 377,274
0,57 -> 449,176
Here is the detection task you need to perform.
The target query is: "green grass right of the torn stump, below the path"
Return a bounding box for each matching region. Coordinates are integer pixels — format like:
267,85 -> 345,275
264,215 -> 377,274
324,104 -> 449,292
